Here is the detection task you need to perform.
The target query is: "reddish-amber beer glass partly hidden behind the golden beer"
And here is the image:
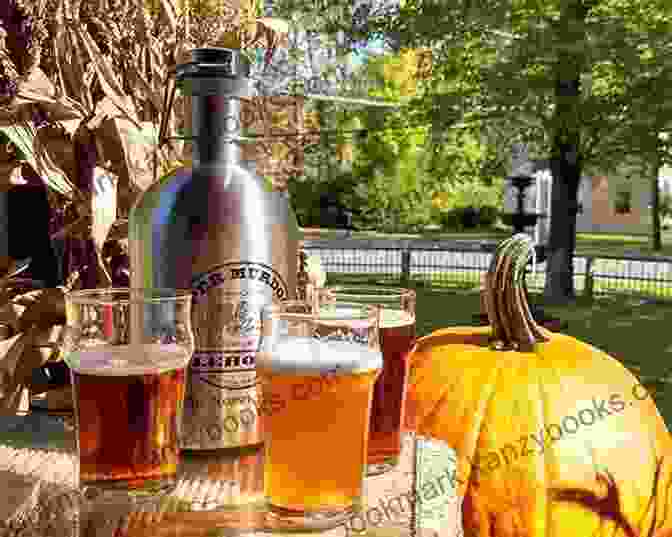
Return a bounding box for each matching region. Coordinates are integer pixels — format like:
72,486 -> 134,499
318,285 -> 415,475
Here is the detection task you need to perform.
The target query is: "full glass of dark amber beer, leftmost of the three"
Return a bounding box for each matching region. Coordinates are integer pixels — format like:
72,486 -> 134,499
63,288 -> 194,500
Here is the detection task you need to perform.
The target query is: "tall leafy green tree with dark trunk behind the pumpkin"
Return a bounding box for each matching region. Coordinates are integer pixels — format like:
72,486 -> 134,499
378,0 -> 671,301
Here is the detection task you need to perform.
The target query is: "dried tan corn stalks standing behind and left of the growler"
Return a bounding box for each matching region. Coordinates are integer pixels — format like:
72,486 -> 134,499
0,0 -> 312,412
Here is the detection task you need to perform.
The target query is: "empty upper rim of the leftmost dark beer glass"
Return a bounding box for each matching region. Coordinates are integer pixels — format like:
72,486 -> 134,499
65,287 -> 193,305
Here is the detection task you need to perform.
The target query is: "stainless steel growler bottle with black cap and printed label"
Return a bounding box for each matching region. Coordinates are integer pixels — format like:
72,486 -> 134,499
129,48 -> 298,450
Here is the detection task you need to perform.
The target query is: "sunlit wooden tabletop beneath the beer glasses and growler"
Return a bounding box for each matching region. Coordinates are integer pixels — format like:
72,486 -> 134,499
0,412 -> 461,537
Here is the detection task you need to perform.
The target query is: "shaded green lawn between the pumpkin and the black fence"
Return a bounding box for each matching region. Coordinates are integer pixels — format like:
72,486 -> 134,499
416,288 -> 672,430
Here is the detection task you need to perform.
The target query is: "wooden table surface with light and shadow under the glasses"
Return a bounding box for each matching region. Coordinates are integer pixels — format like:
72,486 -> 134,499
0,413 -> 460,537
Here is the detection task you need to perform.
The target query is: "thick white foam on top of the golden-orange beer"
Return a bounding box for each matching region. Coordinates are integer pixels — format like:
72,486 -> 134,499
257,335 -> 383,375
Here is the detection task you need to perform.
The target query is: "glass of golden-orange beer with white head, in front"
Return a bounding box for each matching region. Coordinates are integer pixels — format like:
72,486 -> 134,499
257,302 -> 382,530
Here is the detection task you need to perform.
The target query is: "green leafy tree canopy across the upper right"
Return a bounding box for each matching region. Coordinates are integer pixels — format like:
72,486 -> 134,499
277,0 -> 672,171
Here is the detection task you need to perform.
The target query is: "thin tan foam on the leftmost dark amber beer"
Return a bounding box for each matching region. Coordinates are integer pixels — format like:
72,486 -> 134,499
65,343 -> 190,376
